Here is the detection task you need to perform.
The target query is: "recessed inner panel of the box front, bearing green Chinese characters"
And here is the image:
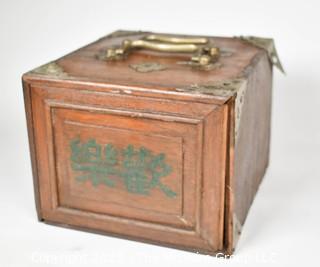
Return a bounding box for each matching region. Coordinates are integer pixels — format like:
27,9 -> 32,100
52,108 -> 197,227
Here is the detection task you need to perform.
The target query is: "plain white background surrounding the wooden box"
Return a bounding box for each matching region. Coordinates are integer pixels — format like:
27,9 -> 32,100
0,0 -> 320,267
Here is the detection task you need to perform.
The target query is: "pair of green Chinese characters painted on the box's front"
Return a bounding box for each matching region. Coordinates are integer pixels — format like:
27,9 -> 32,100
70,138 -> 177,197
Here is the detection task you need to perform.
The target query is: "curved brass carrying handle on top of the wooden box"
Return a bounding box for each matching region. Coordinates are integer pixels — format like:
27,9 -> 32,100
105,34 -> 220,66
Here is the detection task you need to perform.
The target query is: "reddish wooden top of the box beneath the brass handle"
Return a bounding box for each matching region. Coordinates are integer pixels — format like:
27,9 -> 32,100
25,31 -> 267,102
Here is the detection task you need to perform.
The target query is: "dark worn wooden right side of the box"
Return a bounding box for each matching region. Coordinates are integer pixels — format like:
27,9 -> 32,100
225,54 -> 272,254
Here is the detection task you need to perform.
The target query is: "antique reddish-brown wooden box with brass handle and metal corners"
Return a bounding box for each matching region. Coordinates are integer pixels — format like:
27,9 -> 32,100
23,31 -> 278,254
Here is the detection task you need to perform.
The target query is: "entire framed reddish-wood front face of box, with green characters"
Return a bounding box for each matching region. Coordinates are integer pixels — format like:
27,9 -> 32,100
29,86 -> 228,252
